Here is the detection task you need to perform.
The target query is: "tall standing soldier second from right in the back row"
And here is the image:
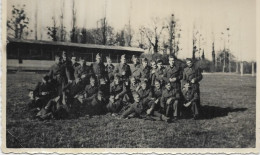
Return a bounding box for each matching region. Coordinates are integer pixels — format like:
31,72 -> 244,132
164,55 -> 183,90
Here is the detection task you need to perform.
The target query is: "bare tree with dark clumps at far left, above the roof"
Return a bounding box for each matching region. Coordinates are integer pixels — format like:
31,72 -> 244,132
7,5 -> 32,39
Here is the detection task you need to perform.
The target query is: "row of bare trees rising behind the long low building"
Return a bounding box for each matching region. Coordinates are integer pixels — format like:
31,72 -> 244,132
7,0 -> 181,55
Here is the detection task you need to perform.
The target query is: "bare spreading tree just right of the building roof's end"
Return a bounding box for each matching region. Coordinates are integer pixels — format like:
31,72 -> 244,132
139,18 -> 166,53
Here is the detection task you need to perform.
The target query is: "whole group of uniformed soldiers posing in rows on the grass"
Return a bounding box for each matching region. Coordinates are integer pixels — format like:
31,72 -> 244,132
29,51 -> 202,122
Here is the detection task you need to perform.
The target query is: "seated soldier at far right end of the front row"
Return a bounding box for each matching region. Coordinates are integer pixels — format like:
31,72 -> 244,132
182,83 -> 200,119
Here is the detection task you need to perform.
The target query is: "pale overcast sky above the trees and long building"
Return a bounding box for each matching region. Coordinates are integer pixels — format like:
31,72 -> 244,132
7,0 -> 256,61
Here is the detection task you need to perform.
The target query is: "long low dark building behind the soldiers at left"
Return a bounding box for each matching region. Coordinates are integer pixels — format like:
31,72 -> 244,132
6,38 -> 144,70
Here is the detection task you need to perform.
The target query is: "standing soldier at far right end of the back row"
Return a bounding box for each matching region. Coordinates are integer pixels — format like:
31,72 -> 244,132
183,58 -> 203,100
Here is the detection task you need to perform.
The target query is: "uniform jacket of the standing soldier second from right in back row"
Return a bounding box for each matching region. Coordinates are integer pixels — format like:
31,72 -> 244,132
164,65 -> 183,83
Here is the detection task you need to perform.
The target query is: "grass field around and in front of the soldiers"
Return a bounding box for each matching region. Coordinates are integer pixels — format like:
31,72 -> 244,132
6,73 -> 256,148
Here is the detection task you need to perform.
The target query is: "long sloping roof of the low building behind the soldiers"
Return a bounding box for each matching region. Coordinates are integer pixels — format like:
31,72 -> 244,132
7,38 -> 144,53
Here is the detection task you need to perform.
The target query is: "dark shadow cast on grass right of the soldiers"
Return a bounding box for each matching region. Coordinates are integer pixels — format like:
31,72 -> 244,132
201,105 -> 247,119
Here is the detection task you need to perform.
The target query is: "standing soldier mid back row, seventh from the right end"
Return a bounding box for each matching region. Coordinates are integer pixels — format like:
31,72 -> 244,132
114,55 -> 132,82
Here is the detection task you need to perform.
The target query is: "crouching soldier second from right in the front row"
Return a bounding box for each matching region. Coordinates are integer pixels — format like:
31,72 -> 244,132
161,80 -> 180,119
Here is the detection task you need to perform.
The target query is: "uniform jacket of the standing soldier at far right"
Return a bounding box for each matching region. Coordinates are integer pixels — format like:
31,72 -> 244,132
183,65 -> 203,83
